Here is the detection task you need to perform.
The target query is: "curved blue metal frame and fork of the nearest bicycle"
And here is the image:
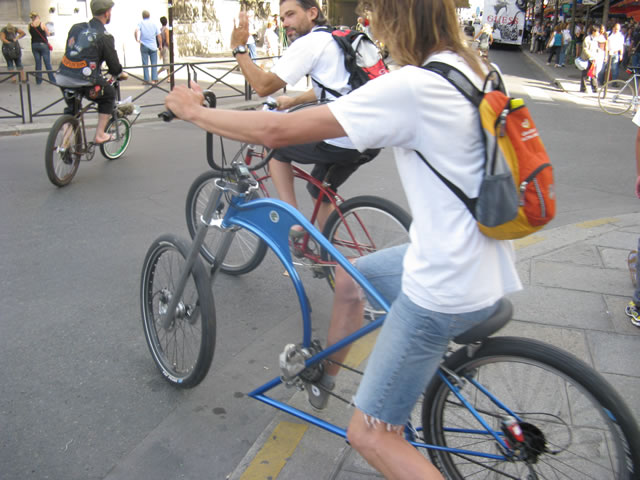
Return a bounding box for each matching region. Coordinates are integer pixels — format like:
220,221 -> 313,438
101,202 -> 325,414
163,170 -> 520,461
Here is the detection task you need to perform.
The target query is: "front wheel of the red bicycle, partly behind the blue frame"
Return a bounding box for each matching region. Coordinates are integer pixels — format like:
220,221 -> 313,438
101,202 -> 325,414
185,170 -> 267,275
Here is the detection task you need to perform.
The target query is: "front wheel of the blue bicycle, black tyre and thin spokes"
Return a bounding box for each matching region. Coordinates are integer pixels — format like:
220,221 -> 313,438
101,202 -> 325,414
140,235 -> 216,388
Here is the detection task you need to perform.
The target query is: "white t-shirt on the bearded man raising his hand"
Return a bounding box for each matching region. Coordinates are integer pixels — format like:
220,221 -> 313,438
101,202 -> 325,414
271,27 -> 355,149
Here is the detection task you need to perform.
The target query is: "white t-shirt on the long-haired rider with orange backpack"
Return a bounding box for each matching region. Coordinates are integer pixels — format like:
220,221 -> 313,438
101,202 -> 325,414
329,52 -> 522,313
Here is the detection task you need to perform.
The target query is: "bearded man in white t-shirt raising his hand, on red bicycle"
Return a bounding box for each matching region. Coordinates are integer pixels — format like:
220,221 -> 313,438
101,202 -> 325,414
231,0 -> 380,237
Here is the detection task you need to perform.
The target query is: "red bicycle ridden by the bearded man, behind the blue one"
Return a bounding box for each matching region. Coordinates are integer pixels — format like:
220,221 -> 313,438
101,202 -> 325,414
186,103 -> 411,288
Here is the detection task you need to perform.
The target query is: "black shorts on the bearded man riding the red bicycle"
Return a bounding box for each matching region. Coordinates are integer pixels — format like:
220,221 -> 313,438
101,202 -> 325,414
273,142 -> 380,202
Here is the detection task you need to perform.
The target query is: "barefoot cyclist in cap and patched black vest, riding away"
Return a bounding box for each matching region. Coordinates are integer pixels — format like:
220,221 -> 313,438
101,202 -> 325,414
56,0 -> 128,143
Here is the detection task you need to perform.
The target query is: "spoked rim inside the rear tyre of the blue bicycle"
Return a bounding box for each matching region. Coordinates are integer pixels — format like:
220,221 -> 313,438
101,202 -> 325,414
423,340 -> 632,480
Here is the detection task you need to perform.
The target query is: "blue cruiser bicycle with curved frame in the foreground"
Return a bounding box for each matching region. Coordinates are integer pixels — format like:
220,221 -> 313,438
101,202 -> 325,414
140,100 -> 640,480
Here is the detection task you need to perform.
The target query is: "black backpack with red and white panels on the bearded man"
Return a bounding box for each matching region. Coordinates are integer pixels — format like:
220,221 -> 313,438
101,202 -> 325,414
313,25 -> 389,100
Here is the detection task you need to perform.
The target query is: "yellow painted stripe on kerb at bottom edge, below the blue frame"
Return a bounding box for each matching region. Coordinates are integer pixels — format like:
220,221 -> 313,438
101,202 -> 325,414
240,422 -> 308,480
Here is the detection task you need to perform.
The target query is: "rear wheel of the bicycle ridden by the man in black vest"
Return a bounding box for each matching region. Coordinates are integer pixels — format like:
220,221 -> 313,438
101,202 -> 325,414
44,115 -> 82,187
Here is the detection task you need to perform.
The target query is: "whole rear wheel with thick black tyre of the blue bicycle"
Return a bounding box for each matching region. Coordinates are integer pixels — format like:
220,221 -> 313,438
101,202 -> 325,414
421,337 -> 640,480
